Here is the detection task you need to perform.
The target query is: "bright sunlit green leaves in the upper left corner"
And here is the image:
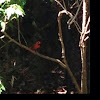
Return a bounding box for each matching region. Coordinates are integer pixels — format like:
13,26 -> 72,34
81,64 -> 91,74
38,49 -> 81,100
0,0 -> 26,32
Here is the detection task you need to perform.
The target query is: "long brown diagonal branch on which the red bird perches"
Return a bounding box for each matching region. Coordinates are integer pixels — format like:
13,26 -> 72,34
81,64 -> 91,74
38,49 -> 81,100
4,32 -> 81,94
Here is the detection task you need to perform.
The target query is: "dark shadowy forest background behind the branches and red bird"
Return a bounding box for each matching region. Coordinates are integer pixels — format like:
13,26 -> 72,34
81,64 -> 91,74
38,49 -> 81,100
0,0 -> 90,94
